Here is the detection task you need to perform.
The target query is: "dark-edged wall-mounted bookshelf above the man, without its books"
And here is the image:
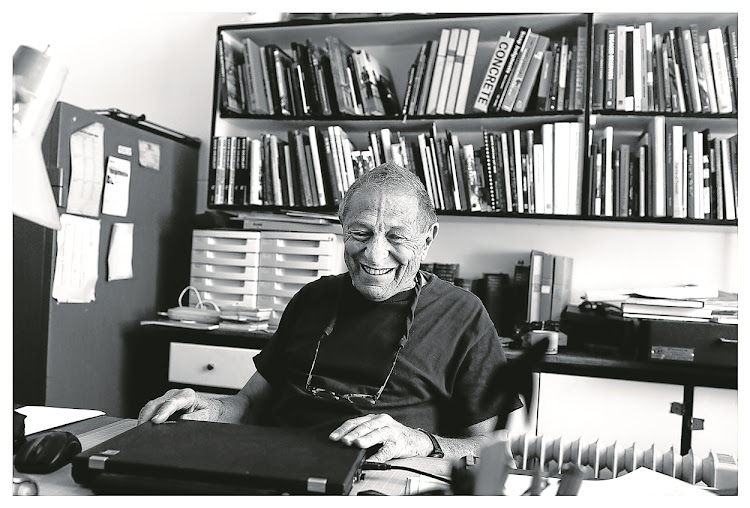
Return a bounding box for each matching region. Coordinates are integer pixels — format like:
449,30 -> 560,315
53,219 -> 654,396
207,13 -> 737,226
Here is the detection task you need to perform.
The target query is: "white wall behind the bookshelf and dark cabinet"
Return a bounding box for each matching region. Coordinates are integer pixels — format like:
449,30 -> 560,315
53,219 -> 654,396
6,7 -> 739,301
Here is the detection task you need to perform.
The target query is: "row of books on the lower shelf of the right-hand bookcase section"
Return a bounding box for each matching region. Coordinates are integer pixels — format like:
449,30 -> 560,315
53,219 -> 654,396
583,123 -> 739,220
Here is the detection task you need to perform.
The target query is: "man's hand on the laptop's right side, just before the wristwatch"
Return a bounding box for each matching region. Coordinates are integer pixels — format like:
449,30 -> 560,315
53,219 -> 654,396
328,414 -> 432,462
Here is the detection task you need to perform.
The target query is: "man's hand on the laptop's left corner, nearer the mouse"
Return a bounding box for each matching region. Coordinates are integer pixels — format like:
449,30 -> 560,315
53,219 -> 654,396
138,388 -> 224,425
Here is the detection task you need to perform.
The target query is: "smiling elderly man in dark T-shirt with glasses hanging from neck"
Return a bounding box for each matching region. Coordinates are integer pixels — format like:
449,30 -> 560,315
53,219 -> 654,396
138,163 -> 520,461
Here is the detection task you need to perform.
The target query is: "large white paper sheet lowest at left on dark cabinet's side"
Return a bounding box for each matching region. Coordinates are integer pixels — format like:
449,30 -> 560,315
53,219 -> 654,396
52,213 -> 101,303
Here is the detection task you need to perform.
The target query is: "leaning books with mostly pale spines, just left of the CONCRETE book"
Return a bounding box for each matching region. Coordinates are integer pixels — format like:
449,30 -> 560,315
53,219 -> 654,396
401,28 -> 479,116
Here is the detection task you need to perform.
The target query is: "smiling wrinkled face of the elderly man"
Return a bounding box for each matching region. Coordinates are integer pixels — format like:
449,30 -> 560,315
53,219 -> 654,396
342,189 -> 438,301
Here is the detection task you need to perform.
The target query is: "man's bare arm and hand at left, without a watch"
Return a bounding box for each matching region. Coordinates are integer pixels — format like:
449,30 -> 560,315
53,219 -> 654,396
138,372 -> 271,425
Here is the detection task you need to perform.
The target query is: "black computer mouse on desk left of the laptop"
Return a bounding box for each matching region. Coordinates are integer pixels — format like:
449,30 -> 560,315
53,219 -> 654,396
13,430 -> 81,474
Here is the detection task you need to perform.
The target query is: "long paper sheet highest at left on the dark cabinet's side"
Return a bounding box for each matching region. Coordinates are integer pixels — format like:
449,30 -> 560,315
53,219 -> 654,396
66,122 -> 104,217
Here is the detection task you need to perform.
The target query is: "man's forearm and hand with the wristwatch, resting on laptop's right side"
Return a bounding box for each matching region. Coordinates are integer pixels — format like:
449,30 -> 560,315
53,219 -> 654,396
329,414 -> 497,462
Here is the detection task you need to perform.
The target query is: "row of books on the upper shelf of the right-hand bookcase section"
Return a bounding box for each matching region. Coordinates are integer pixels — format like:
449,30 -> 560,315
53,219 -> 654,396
591,22 -> 738,113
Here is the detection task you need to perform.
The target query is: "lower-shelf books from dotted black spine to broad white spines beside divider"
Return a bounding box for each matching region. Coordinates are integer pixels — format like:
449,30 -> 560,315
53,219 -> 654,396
482,122 -> 583,215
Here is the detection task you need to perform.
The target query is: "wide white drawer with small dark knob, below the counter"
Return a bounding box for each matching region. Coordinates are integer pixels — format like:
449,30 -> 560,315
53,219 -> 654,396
169,342 -> 260,390
